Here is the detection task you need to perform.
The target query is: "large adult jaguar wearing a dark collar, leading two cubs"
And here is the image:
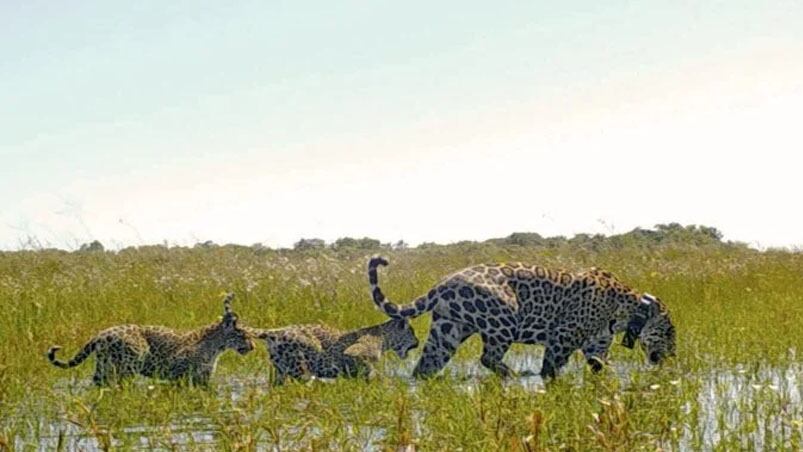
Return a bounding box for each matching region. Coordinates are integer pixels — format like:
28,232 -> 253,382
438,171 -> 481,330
368,257 -> 675,379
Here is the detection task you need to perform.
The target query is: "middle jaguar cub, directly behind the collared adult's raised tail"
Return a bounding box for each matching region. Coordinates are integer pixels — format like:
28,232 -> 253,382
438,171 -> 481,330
250,319 -> 418,384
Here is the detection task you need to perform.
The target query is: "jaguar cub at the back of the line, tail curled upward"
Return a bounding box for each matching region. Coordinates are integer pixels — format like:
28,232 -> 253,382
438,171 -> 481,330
47,293 -> 254,386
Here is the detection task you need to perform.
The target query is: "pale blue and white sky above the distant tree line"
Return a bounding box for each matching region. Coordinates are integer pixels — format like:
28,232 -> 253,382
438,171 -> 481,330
0,0 -> 803,249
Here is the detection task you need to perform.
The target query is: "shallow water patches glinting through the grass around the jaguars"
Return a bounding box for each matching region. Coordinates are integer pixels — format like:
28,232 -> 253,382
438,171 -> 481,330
15,352 -> 803,451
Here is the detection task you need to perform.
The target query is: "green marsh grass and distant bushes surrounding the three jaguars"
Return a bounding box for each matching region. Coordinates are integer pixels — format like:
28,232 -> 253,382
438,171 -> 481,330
0,225 -> 803,450
